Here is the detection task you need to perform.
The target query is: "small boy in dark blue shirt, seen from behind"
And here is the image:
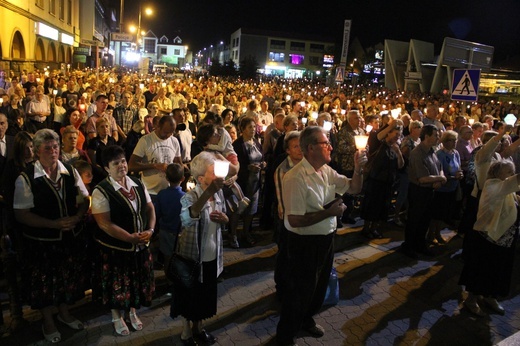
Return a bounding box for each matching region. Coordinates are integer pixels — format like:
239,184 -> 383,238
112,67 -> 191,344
155,163 -> 185,266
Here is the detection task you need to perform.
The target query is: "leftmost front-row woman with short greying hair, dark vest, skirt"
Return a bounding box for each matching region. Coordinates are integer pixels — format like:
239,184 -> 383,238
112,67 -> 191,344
13,129 -> 88,343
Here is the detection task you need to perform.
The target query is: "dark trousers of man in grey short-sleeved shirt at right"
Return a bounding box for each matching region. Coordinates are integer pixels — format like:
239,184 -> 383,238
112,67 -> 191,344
403,183 -> 434,251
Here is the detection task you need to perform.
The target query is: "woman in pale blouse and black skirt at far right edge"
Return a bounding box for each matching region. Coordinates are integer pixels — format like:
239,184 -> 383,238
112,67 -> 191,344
459,159 -> 520,316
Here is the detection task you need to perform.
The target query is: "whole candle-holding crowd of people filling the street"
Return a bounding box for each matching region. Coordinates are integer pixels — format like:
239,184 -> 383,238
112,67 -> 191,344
0,66 -> 520,345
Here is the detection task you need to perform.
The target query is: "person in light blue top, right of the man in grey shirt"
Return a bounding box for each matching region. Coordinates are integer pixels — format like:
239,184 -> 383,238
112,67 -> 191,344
428,130 -> 464,244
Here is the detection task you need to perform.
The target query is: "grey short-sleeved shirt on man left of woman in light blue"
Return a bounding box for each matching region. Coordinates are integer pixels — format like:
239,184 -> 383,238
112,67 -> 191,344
408,142 -> 442,186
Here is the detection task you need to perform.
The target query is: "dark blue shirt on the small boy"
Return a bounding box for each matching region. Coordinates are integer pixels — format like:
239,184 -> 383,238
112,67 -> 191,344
155,186 -> 185,233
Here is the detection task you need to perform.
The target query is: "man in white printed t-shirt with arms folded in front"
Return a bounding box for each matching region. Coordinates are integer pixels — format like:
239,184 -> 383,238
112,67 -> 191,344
128,115 -> 182,200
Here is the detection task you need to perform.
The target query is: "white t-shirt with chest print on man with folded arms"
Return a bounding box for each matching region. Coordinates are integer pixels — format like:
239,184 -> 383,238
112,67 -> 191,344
133,131 -> 181,195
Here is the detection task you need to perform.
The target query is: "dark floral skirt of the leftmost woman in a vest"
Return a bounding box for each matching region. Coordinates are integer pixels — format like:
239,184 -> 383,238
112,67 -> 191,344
22,232 -> 88,309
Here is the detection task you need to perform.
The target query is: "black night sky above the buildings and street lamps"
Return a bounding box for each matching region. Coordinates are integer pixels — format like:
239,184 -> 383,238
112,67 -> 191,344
124,0 -> 520,63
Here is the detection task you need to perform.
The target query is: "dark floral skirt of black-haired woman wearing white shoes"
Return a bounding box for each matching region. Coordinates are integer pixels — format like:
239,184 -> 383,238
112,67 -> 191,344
92,245 -> 155,310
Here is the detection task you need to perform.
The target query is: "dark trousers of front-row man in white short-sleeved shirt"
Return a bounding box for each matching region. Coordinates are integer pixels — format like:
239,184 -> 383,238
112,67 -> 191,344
276,231 -> 334,345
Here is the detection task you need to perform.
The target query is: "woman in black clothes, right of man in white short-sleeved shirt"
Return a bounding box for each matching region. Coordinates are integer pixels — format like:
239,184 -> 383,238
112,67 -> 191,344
361,126 -> 404,239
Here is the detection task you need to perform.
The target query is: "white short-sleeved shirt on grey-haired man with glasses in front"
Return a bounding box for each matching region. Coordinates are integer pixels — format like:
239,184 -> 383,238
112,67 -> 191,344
282,158 -> 350,235
